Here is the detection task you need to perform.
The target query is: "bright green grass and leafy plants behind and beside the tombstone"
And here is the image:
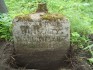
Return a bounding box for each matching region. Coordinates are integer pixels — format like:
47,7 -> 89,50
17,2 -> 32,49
0,0 -> 93,63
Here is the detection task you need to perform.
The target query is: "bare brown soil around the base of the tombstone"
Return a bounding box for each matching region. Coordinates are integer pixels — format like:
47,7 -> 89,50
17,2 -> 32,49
0,41 -> 93,70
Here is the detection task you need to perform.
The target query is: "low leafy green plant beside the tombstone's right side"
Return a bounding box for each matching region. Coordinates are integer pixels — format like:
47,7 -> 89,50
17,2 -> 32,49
71,32 -> 89,48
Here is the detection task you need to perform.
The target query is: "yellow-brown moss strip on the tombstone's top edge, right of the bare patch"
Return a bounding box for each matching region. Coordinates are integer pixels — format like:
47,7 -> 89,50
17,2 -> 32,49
41,13 -> 63,21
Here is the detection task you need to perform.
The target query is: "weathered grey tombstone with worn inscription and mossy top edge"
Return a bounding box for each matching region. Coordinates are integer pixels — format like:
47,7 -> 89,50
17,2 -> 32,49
13,4 -> 70,70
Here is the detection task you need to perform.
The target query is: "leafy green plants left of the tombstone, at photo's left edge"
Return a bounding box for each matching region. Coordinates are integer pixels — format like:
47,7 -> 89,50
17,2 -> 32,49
0,14 -> 11,40
